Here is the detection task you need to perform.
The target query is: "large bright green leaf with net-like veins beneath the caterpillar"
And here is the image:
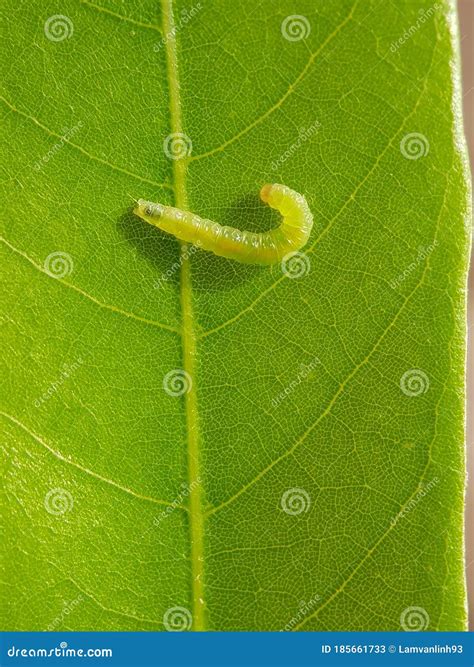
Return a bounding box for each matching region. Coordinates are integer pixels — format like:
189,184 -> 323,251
2,0 -> 469,630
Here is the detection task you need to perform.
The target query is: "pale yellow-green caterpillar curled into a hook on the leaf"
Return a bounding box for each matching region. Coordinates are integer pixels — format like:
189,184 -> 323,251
133,183 -> 313,264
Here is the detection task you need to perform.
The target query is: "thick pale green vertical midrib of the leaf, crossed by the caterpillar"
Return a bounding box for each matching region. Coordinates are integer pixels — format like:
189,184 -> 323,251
161,0 -> 205,630
